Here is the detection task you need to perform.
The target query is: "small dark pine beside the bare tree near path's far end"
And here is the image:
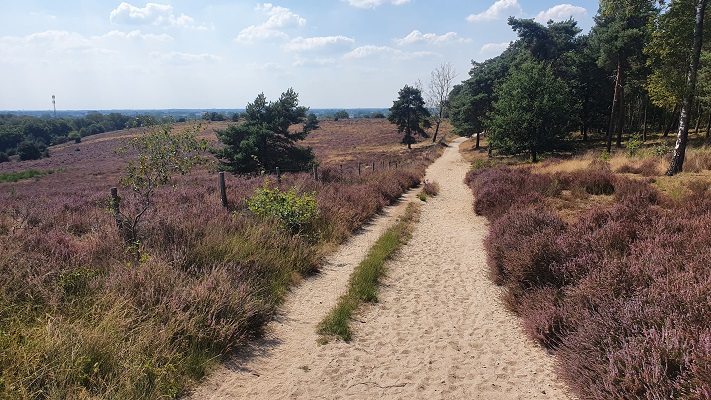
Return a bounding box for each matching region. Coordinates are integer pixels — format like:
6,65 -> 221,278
388,85 -> 431,149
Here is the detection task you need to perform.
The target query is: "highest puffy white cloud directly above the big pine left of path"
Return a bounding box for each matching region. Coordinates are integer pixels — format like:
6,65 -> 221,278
235,3 -> 306,44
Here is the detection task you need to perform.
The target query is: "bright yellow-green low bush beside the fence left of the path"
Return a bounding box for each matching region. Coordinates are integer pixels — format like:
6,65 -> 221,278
247,182 -> 318,235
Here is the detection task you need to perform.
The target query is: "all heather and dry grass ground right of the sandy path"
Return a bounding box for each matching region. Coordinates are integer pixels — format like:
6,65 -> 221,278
467,147 -> 711,399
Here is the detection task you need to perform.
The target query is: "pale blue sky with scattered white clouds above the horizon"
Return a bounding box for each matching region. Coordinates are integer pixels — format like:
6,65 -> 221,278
0,0 -> 598,110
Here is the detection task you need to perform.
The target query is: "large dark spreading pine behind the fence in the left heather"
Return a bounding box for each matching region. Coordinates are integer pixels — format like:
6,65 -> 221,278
213,89 -> 318,173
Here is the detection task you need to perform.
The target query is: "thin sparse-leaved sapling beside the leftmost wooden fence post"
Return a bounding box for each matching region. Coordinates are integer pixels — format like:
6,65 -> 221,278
116,125 -> 208,242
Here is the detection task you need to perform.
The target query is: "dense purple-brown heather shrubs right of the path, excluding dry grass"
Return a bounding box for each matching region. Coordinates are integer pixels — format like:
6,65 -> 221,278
474,161 -> 711,399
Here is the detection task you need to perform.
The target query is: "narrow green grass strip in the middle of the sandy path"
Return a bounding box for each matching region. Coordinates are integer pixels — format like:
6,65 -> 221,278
318,203 -> 420,343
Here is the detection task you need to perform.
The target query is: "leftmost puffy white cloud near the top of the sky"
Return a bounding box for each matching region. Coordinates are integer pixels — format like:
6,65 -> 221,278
109,2 -> 207,30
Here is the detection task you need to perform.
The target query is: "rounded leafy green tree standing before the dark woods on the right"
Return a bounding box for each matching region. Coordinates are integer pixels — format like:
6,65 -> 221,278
487,59 -> 574,162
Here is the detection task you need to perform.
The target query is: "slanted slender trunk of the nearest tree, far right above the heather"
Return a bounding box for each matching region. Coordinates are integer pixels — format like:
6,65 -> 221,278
667,0 -> 708,176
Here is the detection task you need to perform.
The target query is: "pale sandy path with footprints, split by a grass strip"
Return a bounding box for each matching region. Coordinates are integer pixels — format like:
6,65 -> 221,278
193,139 -> 568,399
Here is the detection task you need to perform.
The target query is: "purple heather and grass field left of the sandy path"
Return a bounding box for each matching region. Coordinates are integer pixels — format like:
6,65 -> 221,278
0,119 -> 440,399
